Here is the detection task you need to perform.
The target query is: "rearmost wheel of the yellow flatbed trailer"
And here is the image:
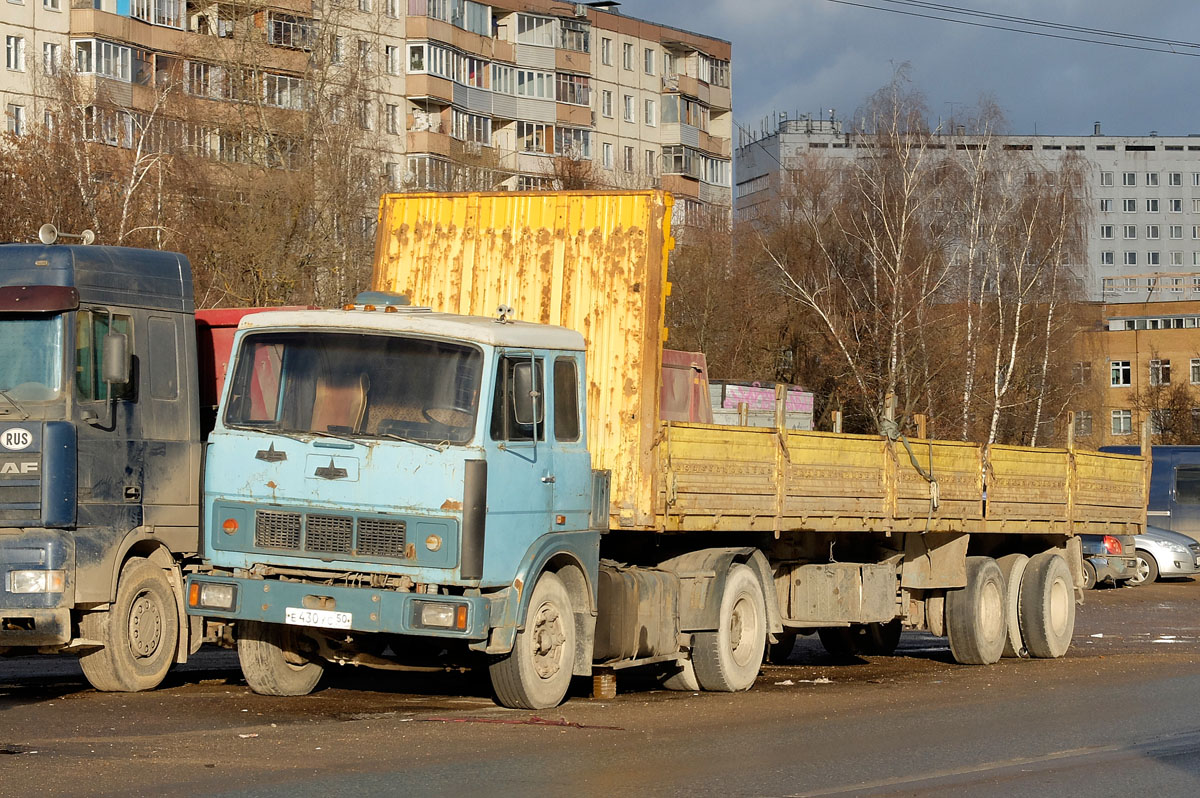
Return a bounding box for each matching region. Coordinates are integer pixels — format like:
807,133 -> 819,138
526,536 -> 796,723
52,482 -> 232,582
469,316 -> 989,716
1020,551 -> 1075,659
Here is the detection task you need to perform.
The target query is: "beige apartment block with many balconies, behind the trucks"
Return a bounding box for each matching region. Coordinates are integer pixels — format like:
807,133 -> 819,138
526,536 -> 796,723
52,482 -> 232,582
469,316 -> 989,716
0,0 -> 732,221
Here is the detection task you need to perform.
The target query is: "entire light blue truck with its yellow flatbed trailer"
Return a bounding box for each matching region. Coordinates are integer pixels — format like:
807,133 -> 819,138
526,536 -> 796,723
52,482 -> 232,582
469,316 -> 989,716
188,192 -> 1146,707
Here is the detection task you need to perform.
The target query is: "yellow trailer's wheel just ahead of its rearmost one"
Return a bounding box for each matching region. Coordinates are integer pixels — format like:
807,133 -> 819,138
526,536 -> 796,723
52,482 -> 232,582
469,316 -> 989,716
946,557 -> 1008,665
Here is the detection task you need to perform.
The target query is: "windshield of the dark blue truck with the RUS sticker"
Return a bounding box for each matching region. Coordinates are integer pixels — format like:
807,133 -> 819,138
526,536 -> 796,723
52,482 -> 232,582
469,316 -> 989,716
0,313 -> 64,402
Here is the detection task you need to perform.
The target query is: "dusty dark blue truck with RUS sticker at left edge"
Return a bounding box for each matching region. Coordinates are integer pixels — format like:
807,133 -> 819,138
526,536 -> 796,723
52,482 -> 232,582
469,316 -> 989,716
0,237 -> 272,690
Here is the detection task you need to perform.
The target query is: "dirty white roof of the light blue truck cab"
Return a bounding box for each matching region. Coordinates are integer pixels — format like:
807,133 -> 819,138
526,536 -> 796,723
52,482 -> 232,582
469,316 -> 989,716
238,307 -> 584,350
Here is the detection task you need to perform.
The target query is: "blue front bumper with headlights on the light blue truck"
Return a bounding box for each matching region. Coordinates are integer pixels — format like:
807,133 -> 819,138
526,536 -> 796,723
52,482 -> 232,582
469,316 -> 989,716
187,575 -> 492,641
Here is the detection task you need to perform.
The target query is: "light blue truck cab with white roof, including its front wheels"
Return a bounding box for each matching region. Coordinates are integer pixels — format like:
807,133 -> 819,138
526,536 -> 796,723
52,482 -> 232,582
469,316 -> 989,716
187,305 -> 607,707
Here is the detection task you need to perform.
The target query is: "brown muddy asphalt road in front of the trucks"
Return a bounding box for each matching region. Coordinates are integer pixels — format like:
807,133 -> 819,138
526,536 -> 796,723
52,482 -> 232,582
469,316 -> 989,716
0,582 -> 1200,798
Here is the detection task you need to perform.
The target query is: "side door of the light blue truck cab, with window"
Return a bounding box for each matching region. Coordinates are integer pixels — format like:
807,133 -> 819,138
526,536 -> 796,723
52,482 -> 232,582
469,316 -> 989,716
484,350 -> 557,583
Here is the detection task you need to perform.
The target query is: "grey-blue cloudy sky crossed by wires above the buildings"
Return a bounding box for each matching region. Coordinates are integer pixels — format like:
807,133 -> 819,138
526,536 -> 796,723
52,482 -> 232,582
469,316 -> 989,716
618,0 -> 1200,141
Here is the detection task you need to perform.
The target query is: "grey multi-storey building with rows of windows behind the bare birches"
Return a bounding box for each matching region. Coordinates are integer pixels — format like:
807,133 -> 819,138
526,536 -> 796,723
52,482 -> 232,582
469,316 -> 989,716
734,116 -> 1200,302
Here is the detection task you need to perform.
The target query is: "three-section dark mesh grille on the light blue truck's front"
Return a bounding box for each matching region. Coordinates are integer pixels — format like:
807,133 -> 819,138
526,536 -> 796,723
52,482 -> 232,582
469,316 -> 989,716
254,510 -> 404,558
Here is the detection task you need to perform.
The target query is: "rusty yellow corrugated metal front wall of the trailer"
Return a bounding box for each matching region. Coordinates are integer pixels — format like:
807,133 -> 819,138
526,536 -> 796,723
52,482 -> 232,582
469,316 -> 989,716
372,191 -> 673,528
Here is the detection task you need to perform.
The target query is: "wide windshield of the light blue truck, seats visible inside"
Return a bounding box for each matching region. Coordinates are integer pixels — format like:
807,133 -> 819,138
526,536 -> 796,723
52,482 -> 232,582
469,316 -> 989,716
224,331 -> 482,444
